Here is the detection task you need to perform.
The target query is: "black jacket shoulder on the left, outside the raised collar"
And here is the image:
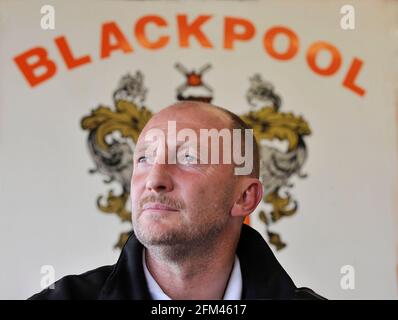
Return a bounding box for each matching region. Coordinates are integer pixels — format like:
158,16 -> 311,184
28,266 -> 114,300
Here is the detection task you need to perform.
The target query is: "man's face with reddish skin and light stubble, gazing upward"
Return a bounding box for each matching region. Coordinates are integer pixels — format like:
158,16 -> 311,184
131,108 -> 235,246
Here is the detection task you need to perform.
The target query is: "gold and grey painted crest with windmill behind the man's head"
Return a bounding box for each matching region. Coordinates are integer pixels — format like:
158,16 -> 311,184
81,69 -> 311,250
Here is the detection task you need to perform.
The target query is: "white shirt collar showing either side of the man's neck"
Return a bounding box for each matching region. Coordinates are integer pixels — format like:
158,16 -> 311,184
142,249 -> 242,300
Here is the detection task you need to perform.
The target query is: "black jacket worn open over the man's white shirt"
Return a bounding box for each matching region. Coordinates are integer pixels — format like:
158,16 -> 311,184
29,225 -> 322,300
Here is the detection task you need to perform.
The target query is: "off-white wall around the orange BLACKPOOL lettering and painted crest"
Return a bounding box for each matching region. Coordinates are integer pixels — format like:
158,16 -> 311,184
0,0 -> 398,299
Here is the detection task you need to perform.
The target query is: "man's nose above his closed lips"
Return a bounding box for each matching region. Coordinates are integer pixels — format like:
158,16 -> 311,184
146,162 -> 173,192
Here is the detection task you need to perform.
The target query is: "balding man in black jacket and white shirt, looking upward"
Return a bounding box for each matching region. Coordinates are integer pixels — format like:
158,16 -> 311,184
31,102 -> 321,300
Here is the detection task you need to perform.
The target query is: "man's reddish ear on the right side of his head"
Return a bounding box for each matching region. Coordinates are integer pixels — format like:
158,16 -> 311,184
231,177 -> 263,218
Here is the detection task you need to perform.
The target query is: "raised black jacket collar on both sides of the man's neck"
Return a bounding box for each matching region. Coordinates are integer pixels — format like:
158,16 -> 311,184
99,225 -> 296,300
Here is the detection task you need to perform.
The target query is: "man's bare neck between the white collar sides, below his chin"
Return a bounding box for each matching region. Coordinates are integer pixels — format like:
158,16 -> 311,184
145,234 -> 237,300
